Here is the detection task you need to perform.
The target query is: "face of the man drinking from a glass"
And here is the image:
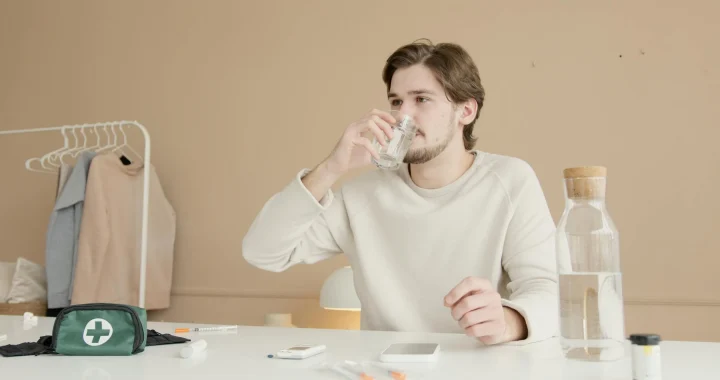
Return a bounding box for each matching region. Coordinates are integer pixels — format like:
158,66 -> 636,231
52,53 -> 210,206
388,65 -> 459,164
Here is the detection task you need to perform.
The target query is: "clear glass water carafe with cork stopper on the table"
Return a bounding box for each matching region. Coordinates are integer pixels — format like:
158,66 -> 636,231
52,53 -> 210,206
556,167 -> 625,361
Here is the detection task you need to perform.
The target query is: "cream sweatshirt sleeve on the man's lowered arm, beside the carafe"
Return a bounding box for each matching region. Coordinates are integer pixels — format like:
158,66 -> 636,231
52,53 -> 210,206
502,162 -> 558,344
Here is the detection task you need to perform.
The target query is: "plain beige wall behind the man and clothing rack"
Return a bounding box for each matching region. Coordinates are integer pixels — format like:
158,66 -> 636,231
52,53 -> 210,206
0,0 -> 720,341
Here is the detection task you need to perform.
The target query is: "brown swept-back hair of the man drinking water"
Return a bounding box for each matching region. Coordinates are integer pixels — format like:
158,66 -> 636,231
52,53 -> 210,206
382,39 -> 485,150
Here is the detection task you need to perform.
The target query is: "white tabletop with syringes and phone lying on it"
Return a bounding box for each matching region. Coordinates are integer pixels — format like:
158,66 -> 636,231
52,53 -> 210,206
0,316 -> 720,380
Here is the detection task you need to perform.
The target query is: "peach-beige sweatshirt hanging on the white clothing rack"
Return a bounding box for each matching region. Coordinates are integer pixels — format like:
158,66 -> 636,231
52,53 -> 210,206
72,153 -> 175,309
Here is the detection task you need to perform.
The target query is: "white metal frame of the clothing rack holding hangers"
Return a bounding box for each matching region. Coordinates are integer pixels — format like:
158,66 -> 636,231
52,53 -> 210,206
0,121 -> 150,308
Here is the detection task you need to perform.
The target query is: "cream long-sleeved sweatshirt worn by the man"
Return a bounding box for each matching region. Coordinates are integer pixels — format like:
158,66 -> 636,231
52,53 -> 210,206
243,151 -> 558,344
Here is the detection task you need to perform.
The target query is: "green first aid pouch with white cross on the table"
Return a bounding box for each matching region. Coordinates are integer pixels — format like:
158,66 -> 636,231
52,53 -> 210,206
49,303 -> 147,356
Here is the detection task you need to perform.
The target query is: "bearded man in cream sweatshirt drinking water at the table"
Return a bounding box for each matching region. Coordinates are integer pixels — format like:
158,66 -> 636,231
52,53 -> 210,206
243,42 -> 558,344
